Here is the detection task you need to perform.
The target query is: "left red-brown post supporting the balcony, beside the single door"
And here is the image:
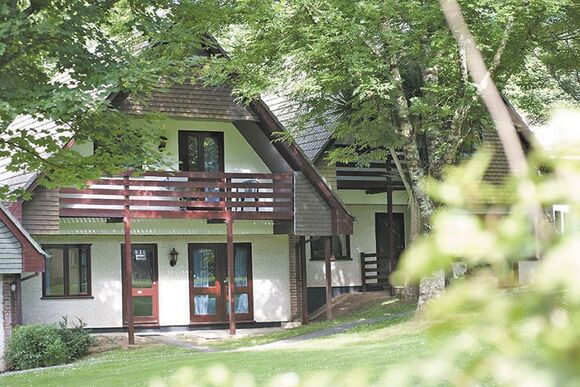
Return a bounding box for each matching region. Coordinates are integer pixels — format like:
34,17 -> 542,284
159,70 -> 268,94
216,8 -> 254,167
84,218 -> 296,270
123,174 -> 135,345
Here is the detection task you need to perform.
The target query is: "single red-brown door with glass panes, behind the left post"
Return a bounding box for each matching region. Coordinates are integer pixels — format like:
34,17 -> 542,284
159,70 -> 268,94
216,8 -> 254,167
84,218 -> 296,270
121,244 -> 159,325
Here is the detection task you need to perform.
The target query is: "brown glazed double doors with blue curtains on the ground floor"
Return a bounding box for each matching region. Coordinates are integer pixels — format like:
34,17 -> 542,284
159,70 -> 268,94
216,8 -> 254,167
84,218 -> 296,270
189,243 -> 253,324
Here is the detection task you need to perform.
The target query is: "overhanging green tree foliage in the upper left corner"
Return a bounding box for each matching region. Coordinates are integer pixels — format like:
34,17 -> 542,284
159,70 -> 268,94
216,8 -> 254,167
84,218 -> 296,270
0,0 -> 224,199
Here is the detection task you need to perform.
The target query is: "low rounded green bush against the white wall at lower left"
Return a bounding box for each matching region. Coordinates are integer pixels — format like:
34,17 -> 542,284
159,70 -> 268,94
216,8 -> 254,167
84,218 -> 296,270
6,317 -> 94,370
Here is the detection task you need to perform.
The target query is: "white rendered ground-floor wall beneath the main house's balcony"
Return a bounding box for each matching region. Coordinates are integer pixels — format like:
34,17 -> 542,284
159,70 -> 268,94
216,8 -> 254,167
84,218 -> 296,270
22,235 -> 290,327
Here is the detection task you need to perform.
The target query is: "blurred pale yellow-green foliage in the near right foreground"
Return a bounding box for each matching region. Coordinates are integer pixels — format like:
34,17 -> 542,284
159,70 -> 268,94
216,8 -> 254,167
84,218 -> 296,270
154,108 -> 580,386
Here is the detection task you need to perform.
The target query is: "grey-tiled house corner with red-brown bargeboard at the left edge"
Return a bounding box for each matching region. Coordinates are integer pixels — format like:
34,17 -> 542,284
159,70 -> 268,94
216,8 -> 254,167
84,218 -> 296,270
0,205 -> 46,371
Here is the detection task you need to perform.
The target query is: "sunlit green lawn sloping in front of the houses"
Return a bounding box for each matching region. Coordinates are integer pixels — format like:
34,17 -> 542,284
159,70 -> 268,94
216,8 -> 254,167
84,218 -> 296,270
0,304 -> 435,386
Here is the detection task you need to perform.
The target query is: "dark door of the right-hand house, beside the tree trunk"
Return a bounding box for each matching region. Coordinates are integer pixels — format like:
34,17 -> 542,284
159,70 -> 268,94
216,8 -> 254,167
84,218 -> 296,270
375,212 -> 405,288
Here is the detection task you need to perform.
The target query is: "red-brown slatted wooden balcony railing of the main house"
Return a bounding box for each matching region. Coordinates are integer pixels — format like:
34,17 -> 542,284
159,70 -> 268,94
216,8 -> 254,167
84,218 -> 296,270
60,172 -> 294,220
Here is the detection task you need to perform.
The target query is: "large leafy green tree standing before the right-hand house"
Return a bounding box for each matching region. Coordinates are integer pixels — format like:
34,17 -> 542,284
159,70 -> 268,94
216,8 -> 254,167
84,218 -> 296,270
197,0 -> 573,306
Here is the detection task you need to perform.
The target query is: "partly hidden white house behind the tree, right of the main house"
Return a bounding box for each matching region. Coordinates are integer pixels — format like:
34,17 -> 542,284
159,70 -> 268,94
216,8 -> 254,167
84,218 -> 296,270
266,96 -> 535,312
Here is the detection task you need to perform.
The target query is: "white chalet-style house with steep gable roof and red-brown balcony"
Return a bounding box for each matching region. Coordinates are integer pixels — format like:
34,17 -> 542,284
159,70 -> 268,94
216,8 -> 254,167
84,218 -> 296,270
2,77 -> 353,344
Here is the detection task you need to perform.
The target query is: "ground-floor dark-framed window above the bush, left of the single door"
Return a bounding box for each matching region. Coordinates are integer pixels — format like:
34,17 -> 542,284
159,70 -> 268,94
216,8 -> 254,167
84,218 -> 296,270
42,245 -> 91,297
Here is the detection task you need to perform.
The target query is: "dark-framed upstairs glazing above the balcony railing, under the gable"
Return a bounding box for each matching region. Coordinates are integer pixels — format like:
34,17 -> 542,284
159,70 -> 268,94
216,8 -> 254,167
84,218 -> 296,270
179,131 -> 224,172
